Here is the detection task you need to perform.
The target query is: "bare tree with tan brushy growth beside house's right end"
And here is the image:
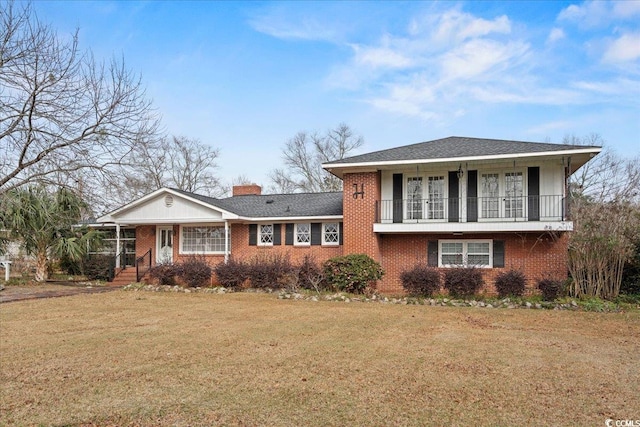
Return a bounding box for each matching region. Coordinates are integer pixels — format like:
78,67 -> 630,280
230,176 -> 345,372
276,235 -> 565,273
564,134 -> 640,299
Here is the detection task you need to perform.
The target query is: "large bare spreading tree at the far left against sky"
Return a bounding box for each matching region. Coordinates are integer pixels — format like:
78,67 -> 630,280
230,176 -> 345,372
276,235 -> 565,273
0,1 -> 158,194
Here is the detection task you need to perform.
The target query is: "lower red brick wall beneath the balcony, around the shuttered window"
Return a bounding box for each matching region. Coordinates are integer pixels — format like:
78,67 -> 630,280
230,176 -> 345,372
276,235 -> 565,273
378,233 -> 568,294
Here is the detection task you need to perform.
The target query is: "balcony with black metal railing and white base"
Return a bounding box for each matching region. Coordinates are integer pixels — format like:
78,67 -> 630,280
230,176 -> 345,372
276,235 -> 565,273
374,195 -> 573,233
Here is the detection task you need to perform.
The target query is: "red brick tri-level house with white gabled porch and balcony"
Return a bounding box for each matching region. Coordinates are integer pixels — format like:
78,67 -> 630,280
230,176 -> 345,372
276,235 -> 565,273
99,137 -> 601,293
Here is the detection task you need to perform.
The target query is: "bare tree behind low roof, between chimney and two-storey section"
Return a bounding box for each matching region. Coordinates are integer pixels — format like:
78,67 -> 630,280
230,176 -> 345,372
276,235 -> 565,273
270,123 -> 364,193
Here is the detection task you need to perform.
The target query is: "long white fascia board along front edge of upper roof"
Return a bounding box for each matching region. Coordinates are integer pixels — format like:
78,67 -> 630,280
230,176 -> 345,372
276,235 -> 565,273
322,147 -> 602,170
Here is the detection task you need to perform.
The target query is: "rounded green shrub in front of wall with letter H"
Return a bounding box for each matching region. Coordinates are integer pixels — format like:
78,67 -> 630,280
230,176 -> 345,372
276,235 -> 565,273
324,254 -> 384,293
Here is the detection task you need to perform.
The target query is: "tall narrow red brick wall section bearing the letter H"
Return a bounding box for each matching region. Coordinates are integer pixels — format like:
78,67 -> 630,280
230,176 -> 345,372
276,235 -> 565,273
342,172 -> 380,262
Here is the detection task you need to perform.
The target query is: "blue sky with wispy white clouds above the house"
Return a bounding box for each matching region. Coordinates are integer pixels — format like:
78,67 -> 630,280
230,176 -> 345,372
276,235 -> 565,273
34,0 -> 640,186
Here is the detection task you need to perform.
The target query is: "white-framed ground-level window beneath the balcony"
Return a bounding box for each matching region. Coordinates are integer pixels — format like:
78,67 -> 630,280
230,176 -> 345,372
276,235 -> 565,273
438,240 -> 493,267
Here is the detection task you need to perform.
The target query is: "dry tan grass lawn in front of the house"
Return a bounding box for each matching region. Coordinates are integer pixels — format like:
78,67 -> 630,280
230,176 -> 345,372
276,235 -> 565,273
0,291 -> 640,426
